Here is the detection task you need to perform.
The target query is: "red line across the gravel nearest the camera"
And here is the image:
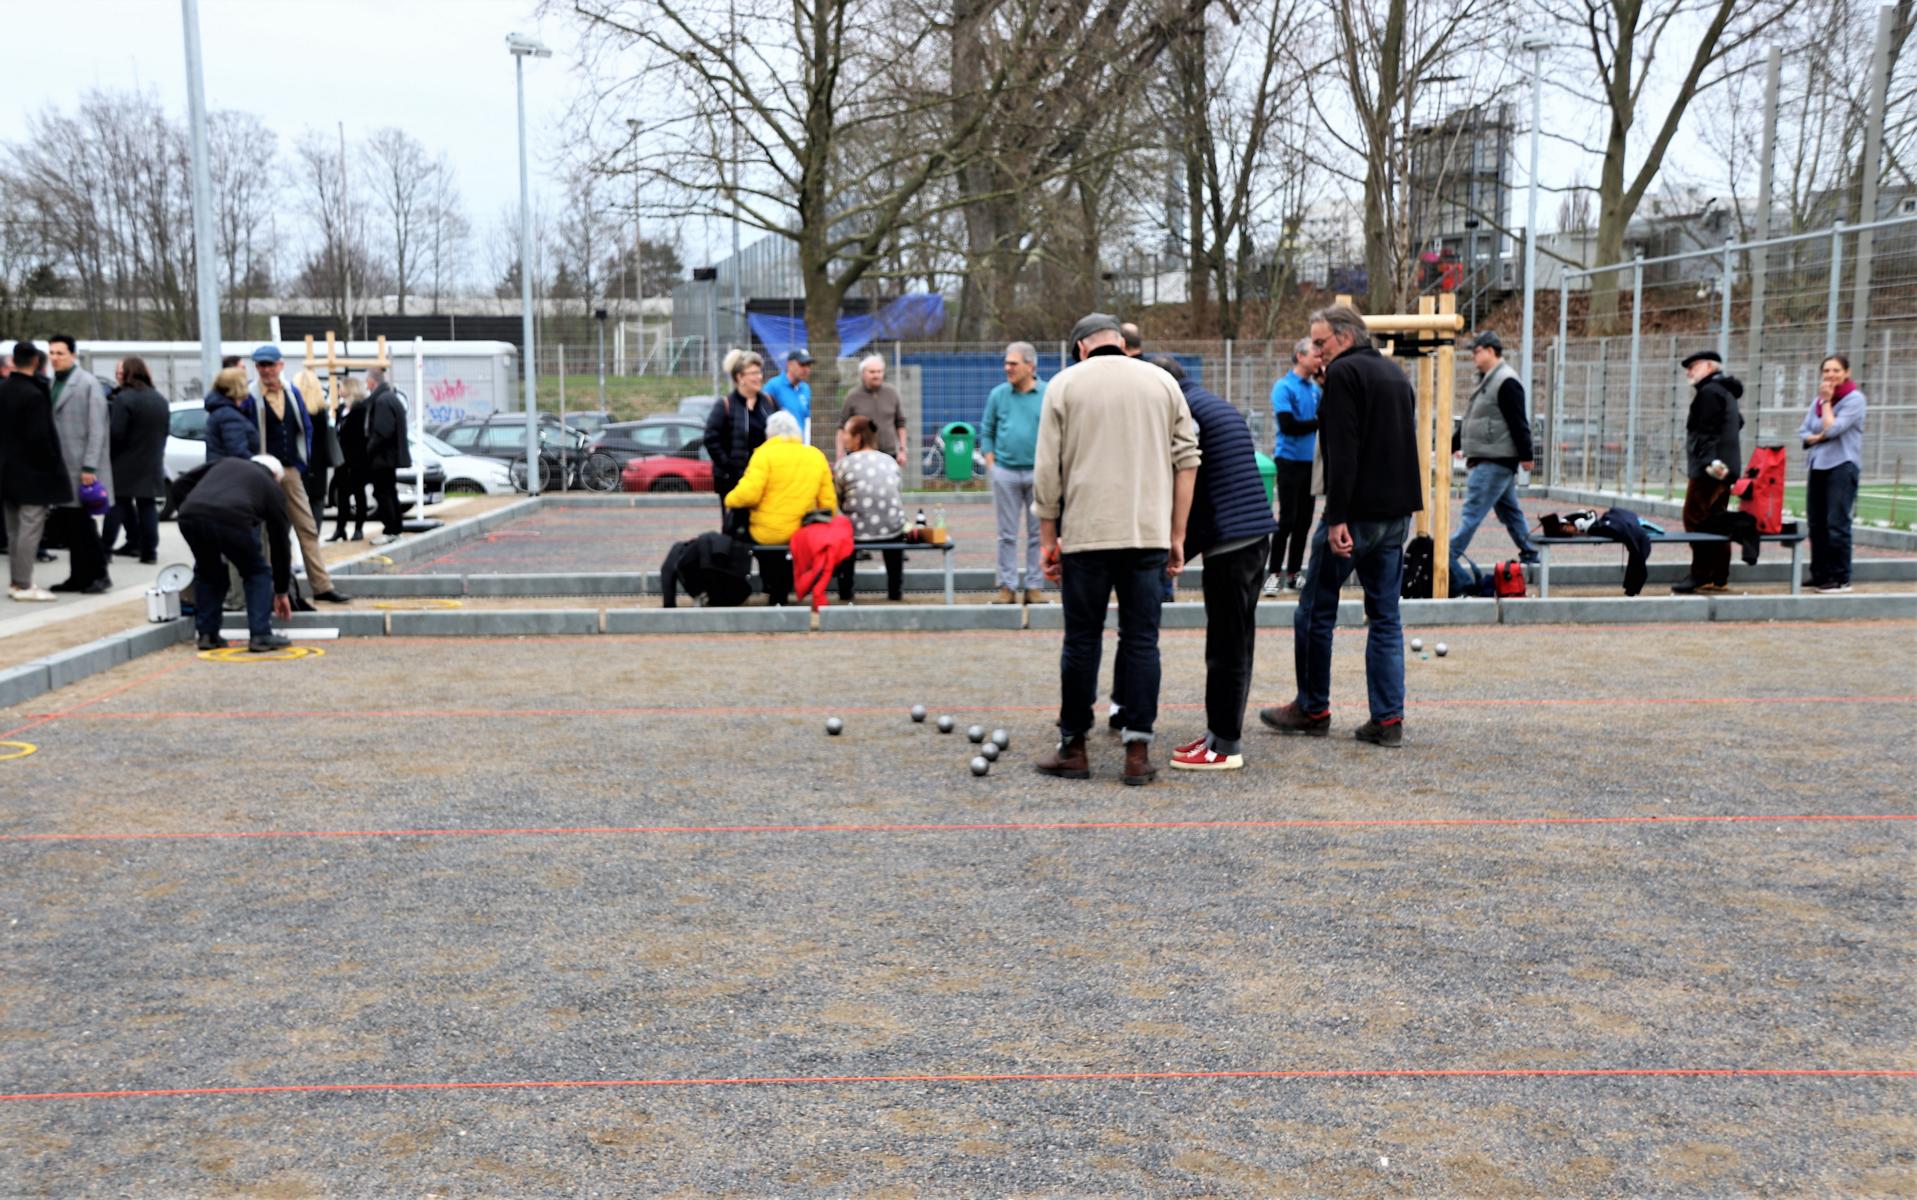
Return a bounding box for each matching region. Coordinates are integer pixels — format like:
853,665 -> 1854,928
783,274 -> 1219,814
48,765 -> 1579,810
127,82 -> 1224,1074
0,1066 -> 1917,1104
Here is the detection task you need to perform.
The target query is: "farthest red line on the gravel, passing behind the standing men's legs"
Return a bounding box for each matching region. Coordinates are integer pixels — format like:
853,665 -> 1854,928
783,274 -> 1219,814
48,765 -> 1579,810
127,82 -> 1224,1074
18,681 -> 1917,720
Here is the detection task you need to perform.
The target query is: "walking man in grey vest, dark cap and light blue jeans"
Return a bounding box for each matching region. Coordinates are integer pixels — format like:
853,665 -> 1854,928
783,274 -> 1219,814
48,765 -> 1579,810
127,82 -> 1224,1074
1451,330 -> 1537,587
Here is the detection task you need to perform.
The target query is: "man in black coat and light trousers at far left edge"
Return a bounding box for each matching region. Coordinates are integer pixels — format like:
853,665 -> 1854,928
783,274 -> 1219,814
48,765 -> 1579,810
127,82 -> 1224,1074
0,341 -> 73,604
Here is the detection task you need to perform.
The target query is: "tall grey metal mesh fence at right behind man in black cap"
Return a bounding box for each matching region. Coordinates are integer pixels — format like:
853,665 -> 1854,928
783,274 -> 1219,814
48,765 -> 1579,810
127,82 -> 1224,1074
1536,217 -> 1917,498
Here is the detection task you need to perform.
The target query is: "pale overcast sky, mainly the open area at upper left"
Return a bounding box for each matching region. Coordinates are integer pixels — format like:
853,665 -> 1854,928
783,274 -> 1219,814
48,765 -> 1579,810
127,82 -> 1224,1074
0,0 -> 1725,274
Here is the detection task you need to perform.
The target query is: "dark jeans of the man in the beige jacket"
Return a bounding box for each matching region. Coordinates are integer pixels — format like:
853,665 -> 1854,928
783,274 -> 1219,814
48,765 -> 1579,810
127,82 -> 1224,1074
1058,550 -> 1166,742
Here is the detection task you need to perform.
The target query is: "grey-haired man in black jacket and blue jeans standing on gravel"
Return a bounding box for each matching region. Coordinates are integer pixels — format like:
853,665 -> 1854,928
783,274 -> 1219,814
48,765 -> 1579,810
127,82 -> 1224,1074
1258,305 -> 1424,746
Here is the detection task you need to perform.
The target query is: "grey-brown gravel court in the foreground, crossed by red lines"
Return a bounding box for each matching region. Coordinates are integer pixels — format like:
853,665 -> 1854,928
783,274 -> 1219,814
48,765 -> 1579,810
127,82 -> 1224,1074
0,623 -> 1917,1194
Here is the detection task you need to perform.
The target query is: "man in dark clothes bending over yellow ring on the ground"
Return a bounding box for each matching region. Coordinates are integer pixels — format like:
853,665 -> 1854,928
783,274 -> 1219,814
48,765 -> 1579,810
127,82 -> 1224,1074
173,454 -> 293,654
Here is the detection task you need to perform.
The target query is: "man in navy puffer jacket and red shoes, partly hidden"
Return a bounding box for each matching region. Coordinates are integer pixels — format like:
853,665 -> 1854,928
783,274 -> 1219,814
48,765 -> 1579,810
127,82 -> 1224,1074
1152,355 -> 1277,771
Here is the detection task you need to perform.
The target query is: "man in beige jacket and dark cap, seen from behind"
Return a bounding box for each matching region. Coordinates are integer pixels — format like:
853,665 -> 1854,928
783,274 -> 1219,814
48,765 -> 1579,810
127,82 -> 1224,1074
1033,312 -> 1198,784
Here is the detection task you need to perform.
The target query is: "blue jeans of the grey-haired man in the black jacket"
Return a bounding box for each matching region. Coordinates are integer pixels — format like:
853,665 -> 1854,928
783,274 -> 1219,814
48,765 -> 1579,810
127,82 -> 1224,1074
1292,516 -> 1411,721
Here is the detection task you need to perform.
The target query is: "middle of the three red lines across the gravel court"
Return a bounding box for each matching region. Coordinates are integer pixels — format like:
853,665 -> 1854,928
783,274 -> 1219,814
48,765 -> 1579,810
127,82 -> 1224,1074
0,813 -> 1917,842
